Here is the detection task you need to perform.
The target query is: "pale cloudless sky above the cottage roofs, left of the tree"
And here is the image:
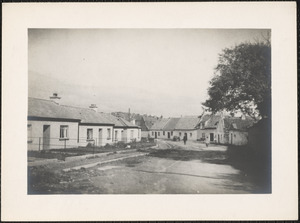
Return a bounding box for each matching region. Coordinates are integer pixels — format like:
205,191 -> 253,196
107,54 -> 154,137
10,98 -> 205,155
28,29 -> 269,117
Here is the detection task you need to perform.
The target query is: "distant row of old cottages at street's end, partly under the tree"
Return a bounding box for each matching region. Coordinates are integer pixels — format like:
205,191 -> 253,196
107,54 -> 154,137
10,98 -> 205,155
144,114 -> 254,145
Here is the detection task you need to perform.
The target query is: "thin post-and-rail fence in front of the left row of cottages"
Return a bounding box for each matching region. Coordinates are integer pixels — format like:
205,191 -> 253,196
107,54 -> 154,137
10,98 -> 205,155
27,137 -> 139,151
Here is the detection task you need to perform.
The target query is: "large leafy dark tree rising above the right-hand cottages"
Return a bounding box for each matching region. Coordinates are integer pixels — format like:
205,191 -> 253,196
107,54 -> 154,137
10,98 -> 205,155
203,41 -> 271,119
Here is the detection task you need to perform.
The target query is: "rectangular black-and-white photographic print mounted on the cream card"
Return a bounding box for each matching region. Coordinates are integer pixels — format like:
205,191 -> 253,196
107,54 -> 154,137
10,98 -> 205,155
27,29 -> 272,194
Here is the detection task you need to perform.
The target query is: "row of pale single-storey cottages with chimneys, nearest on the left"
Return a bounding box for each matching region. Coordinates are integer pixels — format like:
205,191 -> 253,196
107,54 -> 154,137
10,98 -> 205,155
27,94 -> 141,150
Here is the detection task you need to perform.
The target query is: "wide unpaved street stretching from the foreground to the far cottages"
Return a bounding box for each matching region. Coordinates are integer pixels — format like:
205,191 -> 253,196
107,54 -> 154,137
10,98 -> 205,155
30,140 -> 260,194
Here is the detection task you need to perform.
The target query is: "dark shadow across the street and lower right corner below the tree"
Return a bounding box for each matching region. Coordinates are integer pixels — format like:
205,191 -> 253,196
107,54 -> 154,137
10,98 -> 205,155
149,146 -> 271,193
